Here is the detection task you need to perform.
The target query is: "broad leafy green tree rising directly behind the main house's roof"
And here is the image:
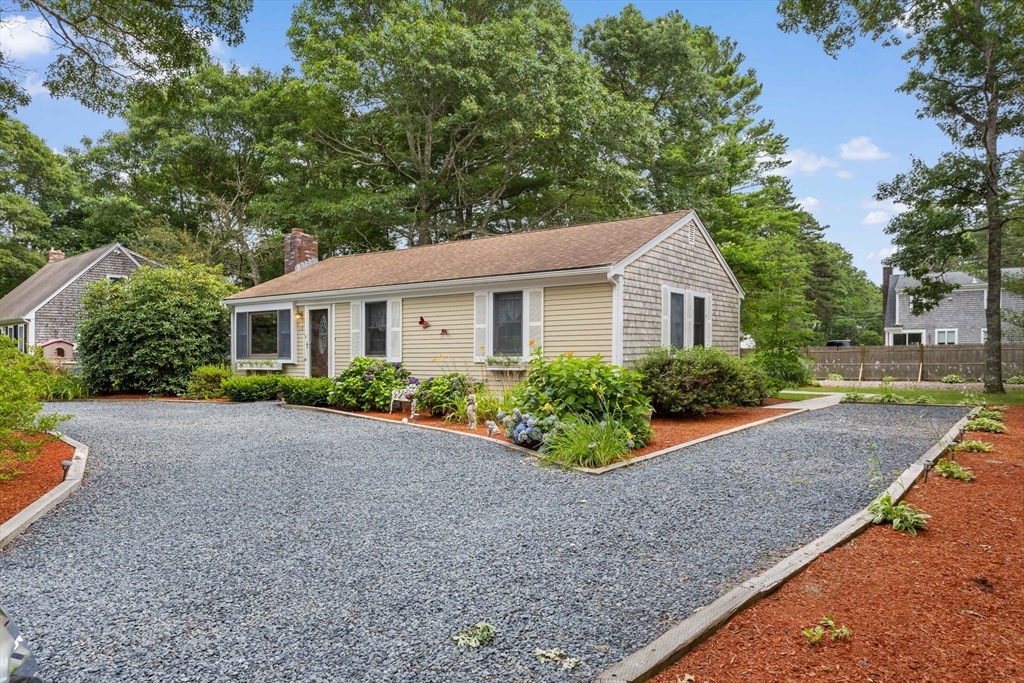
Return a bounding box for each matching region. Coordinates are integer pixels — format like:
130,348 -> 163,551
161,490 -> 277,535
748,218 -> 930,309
289,0 -> 648,245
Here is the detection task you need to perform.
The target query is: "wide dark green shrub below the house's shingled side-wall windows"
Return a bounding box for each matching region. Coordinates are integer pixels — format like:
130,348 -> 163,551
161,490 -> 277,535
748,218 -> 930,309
634,346 -> 768,416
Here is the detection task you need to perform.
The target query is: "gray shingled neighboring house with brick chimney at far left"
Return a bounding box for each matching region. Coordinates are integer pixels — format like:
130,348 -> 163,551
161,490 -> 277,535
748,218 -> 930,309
0,244 -> 160,359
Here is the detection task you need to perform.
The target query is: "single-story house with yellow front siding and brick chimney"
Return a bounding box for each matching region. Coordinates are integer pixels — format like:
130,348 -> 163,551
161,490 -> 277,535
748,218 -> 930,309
224,211 -> 743,383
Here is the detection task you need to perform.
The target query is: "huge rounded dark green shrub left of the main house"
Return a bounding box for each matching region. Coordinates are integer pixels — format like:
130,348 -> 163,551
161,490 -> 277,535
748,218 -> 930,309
77,263 -> 233,395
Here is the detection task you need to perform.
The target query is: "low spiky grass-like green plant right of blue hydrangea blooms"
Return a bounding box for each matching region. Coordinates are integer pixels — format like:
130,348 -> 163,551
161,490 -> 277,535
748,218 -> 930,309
541,416 -> 632,467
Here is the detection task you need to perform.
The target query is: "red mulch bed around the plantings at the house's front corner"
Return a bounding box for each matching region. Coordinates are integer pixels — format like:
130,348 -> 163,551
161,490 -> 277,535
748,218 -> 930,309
362,408 -> 788,458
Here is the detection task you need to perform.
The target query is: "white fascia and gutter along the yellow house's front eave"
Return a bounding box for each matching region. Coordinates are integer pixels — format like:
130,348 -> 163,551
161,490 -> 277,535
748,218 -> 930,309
222,265 -> 610,310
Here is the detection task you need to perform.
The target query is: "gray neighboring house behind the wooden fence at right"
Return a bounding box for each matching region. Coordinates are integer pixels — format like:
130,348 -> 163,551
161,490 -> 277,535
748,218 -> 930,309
882,266 -> 1024,346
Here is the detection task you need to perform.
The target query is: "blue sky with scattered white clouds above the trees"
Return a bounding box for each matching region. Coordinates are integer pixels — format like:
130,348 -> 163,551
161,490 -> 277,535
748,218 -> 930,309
0,0 -> 946,282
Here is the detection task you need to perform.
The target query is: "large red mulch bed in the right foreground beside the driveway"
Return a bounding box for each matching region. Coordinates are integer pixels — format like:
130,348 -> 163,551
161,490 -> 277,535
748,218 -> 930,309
653,405 -> 1024,683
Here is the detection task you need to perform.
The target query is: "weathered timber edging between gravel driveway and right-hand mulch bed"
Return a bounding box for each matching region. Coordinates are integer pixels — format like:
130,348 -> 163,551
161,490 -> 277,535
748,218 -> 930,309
595,408 -> 981,683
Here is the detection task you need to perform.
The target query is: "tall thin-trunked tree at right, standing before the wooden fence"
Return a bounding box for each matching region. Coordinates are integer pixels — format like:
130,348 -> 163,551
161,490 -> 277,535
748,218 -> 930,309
778,0 -> 1024,392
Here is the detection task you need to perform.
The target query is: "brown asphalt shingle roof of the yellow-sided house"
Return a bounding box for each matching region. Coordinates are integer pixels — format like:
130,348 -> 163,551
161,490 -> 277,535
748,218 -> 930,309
228,211 -> 690,300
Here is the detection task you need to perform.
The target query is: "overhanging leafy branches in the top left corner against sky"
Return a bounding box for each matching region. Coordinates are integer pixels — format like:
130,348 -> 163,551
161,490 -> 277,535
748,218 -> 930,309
0,0 -> 252,115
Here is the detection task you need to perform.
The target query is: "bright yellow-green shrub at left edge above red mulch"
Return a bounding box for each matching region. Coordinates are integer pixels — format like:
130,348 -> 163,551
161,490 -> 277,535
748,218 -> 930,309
0,336 -> 68,480
